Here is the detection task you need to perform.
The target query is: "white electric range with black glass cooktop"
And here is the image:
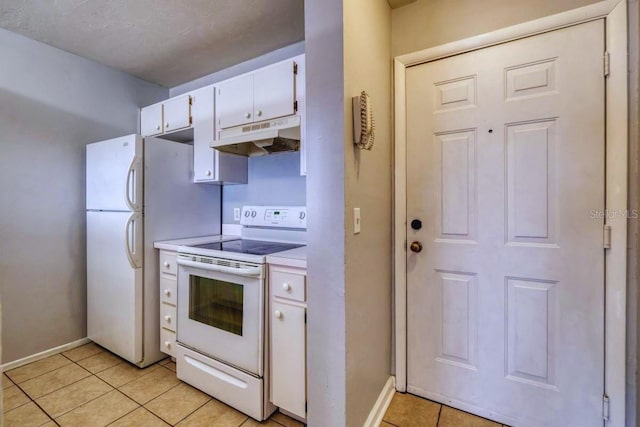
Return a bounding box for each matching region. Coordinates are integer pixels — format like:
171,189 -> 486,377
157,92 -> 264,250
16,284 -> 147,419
176,206 -> 307,421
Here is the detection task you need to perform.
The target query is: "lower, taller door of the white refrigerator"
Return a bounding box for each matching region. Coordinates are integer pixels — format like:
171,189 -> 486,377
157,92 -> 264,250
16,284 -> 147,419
87,212 -> 143,363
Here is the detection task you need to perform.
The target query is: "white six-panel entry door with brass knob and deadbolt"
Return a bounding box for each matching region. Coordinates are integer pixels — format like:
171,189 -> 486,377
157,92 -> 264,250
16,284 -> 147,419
406,20 -> 605,427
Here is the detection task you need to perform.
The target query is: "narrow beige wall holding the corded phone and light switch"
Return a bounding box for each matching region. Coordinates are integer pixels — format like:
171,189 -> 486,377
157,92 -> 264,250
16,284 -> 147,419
344,0 -> 393,426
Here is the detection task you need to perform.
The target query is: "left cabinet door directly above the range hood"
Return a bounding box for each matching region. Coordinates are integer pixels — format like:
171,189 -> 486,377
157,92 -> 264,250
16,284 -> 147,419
216,74 -> 254,129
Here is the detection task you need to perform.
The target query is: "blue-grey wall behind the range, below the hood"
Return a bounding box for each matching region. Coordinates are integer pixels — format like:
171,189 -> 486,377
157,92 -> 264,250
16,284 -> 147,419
222,152 -> 307,224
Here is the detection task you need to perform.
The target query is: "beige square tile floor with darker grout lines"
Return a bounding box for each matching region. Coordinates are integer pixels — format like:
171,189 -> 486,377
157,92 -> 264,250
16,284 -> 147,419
2,343 -> 510,427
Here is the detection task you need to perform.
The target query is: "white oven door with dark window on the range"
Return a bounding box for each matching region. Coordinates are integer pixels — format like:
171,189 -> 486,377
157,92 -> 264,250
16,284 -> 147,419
177,257 -> 264,377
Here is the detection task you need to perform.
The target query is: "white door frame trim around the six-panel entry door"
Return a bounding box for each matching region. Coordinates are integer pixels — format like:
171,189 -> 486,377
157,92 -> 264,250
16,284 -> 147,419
393,0 -> 628,427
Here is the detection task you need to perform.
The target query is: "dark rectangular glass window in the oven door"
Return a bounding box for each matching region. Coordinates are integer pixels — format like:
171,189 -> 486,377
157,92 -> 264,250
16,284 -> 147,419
189,275 -> 244,336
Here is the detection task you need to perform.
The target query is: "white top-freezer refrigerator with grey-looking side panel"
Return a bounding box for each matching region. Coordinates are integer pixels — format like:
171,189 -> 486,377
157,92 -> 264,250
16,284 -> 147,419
86,135 -> 221,367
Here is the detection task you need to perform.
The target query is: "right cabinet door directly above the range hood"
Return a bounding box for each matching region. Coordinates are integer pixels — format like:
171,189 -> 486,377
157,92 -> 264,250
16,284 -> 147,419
253,61 -> 296,122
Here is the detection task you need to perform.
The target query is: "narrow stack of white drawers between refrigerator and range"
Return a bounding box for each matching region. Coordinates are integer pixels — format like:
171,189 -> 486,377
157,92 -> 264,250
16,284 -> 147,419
160,250 -> 178,357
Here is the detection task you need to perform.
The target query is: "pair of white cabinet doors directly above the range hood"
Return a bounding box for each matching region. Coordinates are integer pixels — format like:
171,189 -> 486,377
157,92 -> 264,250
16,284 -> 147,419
216,59 -> 296,129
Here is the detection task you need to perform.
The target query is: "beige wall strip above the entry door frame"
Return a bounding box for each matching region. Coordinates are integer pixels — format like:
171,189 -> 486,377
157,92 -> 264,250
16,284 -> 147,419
391,0 -> 598,56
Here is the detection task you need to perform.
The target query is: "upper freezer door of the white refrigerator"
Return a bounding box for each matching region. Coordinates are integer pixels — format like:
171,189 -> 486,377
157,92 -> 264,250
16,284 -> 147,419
86,135 -> 143,211
